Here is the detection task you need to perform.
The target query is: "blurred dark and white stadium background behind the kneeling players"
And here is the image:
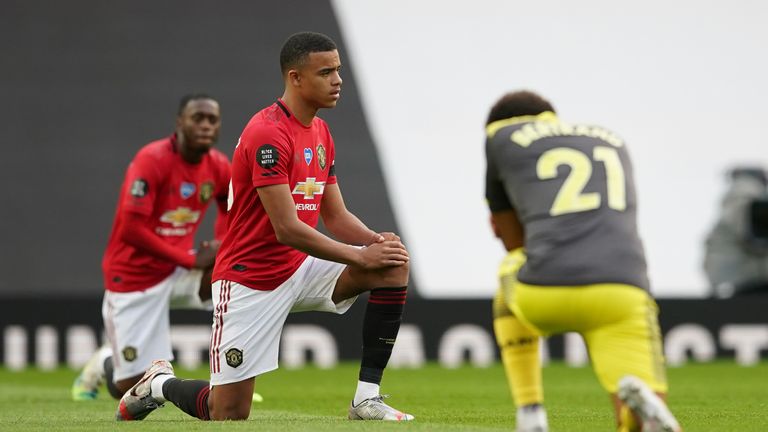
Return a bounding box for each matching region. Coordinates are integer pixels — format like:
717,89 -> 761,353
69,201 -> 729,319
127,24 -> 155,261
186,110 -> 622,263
0,0 -> 768,369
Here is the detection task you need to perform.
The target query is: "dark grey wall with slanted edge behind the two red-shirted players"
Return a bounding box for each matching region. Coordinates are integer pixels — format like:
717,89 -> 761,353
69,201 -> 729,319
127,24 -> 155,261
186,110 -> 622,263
0,0 -> 408,297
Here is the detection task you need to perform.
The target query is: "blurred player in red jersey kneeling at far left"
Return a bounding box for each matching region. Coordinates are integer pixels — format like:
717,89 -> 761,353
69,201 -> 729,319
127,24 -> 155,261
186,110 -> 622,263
72,94 -> 230,400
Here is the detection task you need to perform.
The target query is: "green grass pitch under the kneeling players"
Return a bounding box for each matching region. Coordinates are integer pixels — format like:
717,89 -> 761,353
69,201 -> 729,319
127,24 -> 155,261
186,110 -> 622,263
0,361 -> 768,432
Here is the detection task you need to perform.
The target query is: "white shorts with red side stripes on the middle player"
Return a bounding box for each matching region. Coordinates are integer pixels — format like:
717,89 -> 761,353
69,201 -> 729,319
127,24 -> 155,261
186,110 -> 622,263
210,256 -> 357,386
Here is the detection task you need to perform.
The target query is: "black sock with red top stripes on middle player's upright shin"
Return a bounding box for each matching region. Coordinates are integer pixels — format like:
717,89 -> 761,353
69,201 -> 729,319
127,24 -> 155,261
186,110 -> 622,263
359,287 -> 408,384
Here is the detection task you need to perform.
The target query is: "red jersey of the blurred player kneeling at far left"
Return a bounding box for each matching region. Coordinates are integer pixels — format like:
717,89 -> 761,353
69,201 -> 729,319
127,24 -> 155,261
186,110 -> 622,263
102,135 -> 229,292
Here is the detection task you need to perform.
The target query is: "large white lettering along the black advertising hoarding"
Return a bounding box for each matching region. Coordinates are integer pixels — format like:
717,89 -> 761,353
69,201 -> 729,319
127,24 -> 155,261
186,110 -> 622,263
2,323 -> 768,370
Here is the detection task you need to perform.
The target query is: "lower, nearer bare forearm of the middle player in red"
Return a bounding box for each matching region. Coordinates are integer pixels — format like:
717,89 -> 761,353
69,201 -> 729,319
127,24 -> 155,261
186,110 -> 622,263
275,221 -> 361,265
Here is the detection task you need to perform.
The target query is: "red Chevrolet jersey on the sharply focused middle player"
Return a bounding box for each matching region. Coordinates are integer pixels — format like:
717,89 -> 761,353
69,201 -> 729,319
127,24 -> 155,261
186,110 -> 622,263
213,99 -> 336,291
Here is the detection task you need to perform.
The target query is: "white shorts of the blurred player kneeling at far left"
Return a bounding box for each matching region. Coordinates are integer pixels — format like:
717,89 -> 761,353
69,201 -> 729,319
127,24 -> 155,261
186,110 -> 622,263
101,267 -> 204,381
